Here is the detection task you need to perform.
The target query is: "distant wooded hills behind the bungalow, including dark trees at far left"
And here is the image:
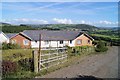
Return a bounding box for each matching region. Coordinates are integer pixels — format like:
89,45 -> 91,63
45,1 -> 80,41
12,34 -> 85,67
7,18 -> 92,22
2,23 -> 99,33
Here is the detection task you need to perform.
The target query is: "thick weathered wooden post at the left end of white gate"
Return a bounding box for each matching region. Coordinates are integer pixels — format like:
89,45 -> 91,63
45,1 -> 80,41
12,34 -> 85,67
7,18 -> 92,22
32,50 -> 38,73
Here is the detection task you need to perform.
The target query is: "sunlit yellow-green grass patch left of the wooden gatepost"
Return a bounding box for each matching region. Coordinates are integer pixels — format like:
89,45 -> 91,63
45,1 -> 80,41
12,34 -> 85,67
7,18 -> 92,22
2,49 -> 32,61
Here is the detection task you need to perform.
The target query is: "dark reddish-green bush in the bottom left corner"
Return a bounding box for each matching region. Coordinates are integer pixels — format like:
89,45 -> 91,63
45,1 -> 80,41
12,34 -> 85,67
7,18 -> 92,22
2,58 -> 34,78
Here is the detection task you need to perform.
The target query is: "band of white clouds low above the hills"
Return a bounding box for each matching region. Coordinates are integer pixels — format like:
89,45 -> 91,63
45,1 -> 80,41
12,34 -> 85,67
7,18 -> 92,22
1,18 -> 118,27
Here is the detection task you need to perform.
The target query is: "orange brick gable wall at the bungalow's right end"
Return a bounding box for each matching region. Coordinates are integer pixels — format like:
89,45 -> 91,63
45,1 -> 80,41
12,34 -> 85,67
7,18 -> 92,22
75,34 -> 92,46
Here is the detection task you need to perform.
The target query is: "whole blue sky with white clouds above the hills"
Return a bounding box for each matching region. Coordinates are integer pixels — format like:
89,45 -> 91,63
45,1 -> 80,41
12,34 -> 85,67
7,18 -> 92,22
0,2 -> 118,27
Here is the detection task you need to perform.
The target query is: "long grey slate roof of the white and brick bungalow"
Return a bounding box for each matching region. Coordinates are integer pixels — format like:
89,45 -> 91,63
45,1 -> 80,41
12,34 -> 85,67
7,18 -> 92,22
23,30 -> 92,41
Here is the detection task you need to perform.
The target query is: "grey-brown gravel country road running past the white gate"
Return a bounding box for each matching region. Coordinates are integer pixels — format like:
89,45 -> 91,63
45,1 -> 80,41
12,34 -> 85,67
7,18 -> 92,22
40,46 -> 118,78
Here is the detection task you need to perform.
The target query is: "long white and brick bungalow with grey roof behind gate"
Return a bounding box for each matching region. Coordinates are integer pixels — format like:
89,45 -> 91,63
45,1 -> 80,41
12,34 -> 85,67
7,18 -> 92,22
10,30 -> 94,48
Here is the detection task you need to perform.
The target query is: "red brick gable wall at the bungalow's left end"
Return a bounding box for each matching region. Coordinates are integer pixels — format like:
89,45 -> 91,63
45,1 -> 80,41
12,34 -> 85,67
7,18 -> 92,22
10,34 -> 31,48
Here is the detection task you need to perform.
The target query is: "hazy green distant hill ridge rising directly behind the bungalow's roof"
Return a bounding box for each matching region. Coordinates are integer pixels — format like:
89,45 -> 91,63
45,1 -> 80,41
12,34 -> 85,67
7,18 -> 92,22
21,24 -> 99,31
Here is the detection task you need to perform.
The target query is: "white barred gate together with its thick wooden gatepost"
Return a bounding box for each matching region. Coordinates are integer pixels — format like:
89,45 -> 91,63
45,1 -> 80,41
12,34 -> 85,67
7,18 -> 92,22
33,48 -> 67,72
